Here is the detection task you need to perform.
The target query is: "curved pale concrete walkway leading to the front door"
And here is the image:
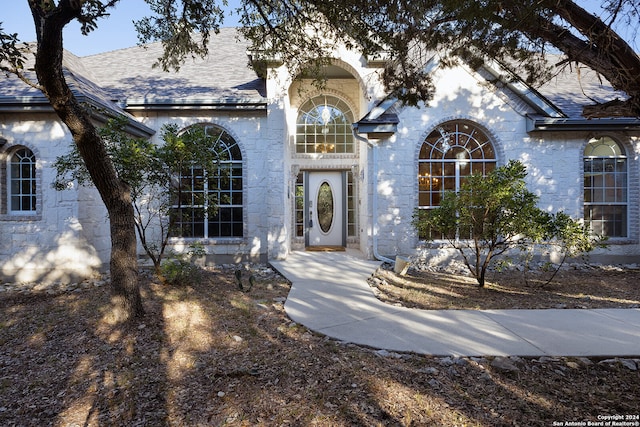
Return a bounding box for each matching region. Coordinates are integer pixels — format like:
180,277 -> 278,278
271,251 -> 640,357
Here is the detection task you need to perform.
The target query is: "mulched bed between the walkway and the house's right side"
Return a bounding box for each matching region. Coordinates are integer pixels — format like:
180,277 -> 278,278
370,264 -> 640,310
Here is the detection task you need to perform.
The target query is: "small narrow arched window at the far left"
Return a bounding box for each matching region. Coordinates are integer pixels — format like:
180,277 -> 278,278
7,148 -> 36,214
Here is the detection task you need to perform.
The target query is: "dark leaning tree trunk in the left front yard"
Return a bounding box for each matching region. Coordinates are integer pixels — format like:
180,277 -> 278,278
29,2 -> 144,320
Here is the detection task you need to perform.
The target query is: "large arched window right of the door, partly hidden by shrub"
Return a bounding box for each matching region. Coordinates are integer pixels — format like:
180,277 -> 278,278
418,121 -> 496,209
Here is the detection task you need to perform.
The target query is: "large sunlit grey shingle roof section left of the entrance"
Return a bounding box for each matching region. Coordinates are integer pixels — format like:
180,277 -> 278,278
82,28 -> 266,110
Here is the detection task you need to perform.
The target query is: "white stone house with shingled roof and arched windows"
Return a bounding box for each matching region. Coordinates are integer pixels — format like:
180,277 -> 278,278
0,29 -> 640,281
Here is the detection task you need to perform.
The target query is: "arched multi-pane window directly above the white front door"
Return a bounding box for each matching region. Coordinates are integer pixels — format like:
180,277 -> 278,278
296,95 -> 355,154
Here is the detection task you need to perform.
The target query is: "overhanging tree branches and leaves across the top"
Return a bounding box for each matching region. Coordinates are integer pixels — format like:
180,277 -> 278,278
0,0 -> 640,117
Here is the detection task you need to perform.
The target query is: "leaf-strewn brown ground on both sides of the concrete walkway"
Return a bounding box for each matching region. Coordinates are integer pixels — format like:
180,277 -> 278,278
0,266 -> 640,426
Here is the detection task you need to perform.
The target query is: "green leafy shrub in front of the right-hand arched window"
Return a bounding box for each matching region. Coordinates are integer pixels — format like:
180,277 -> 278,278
413,160 -> 598,286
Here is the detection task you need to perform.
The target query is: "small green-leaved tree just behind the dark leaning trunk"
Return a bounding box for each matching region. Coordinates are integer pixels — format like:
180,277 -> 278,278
53,118 -> 227,274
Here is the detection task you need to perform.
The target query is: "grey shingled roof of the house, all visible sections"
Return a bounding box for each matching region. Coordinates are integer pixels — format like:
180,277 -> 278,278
0,28 -> 640,133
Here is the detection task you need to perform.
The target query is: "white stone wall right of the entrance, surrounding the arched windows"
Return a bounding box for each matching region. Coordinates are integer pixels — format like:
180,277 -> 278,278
370,67 -> 640,263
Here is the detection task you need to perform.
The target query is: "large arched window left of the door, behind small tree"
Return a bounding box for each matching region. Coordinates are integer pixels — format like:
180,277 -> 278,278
172,125 -> 244,238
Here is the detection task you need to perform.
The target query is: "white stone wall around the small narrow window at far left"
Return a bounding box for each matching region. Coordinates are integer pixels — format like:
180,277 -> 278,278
0,113 -> 109,282
